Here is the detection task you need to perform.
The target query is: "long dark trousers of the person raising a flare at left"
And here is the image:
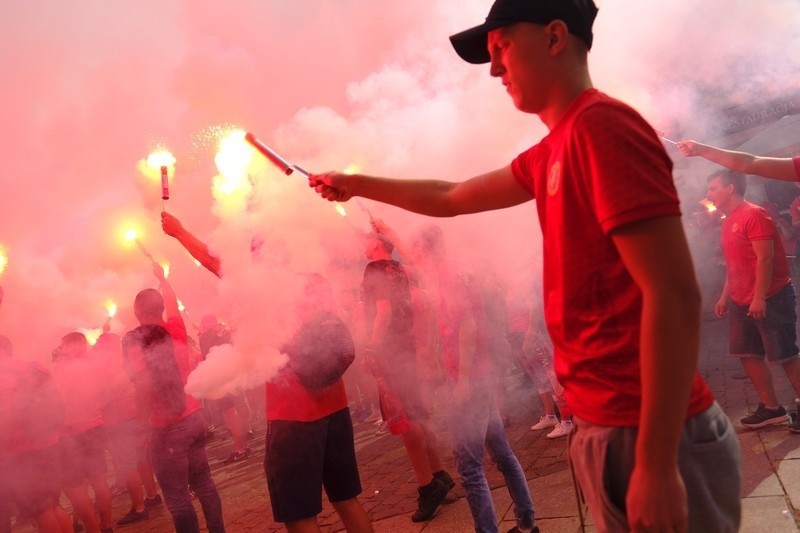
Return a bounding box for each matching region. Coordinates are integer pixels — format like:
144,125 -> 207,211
150,411 -> 225,533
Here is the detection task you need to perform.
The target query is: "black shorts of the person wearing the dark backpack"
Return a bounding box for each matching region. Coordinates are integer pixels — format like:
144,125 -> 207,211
264,408 -> 361,523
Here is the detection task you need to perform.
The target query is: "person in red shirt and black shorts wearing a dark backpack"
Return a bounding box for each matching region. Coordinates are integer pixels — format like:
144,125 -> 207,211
264,274 -> 372,533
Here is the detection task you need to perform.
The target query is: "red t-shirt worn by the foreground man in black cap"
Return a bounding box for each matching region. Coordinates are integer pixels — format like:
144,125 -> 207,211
511,89 -> 714,427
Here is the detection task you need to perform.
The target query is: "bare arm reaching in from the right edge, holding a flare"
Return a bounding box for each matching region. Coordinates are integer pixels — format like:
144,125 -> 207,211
677,141 -> 800,181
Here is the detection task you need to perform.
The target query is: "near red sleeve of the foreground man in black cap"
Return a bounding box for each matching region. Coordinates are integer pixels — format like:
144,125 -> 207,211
573,104 -> 680,234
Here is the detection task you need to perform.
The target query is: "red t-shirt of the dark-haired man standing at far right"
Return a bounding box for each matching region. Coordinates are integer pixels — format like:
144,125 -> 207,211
720,201 -> 791,305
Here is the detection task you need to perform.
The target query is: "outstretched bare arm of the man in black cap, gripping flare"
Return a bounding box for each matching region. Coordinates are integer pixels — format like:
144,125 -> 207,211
309,165 -> 532,217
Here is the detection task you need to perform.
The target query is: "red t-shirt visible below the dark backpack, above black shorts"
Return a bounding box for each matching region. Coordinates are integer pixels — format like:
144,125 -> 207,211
267,368 -> 347,422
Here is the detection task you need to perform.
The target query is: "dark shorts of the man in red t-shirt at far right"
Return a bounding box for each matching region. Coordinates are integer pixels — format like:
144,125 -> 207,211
729,283 -> 798,364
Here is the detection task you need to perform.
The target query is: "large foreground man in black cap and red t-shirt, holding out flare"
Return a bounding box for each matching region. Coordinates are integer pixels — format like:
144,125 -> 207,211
309,0 -> 741,531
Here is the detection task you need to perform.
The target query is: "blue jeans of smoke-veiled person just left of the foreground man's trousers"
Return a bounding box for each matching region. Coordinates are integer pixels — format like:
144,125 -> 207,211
448,385 -> 535,533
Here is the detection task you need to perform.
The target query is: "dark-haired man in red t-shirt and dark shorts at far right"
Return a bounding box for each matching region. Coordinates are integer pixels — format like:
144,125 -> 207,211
708,170 -> 800,433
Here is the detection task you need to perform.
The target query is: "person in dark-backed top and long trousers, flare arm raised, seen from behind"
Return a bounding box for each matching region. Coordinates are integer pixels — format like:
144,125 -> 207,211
122,264 -> 225,533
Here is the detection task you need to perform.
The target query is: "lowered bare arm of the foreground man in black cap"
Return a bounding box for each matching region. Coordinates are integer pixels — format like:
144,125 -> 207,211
611,216 -> 700,531
